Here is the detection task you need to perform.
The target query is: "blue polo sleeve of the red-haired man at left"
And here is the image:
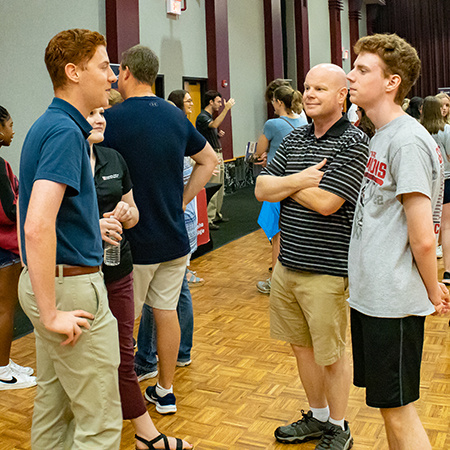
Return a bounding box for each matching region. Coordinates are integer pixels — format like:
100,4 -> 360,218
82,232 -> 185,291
33,128 -> 87,195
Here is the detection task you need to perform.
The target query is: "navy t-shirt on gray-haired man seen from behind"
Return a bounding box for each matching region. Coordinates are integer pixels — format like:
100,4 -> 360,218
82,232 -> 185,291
102,97 -> 206,264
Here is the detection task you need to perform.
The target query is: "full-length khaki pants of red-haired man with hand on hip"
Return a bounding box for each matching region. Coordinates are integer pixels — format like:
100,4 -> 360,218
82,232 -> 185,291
19,268 -> 122,450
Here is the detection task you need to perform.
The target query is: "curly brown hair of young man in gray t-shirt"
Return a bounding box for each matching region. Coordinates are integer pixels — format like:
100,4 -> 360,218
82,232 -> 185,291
355,34 -> 420,105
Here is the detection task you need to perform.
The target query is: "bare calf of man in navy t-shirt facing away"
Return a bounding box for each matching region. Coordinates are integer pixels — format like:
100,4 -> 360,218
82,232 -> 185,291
153,308 -> 180,389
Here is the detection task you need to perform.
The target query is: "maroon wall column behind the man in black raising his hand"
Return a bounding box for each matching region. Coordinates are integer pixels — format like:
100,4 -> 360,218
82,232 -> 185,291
202,0 -> 232,159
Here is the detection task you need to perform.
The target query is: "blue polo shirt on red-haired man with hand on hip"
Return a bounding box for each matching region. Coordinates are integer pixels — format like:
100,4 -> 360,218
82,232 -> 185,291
19,98 -> 103,266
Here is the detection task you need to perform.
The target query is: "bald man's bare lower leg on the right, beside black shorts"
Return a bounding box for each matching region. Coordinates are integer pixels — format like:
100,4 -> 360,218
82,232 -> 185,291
324,354 -> 351,420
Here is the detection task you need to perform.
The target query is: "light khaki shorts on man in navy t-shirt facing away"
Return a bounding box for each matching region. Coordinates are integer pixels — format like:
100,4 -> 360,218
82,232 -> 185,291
133,255 -> 187,319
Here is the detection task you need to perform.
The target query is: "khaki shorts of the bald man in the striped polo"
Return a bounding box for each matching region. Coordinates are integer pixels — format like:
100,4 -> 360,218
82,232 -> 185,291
270,262 -> 349,366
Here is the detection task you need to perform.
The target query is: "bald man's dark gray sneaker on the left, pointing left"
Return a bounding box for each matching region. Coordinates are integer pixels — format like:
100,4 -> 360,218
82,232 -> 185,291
274,409 -> 327,444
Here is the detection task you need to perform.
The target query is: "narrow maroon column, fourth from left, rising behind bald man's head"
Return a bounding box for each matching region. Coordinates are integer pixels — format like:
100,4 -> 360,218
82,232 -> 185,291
295,0 -> 311,87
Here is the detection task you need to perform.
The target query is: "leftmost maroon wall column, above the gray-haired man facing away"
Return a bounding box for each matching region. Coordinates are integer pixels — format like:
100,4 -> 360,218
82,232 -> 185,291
105,0 -> 140,63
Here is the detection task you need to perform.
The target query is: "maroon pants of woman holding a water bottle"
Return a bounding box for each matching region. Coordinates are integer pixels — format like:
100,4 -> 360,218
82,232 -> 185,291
106,273 -> 147,420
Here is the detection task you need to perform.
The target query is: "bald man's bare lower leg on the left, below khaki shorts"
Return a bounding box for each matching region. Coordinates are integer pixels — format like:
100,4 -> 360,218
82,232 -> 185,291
291,344 -> 328,408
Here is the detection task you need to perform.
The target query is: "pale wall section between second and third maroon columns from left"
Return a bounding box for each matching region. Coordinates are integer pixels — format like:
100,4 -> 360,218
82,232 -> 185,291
228,0 -> 267,156
